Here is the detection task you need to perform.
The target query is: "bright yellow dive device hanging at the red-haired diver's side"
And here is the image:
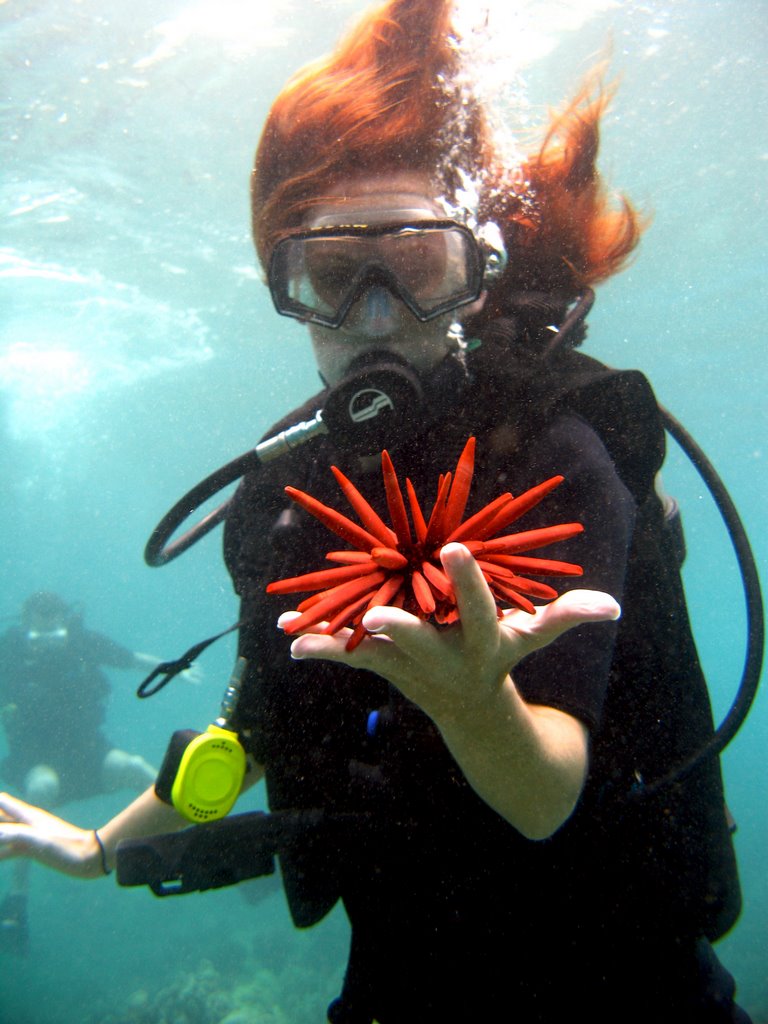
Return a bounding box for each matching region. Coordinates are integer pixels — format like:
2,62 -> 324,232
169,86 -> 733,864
155,657 -> 247,823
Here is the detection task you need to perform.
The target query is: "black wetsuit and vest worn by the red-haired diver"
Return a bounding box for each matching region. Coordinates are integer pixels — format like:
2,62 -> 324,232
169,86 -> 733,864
226,346 -> 742,1024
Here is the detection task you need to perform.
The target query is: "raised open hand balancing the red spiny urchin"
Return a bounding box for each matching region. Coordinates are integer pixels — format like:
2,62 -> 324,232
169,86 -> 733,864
279,544 -> 621,722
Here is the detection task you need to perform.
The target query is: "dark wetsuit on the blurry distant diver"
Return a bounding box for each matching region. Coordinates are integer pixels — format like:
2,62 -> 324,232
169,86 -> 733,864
0,624 -> 135,803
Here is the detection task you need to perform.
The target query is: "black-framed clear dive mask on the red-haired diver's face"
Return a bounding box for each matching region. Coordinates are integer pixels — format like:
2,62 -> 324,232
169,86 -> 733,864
267,210 -> 506,327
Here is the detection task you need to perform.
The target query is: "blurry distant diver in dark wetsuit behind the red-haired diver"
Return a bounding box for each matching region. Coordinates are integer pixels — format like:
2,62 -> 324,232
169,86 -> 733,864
0,591 -> 169,953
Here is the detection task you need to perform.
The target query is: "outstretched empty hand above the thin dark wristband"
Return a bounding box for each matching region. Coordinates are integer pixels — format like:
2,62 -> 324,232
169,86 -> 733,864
0,793 -> 103,879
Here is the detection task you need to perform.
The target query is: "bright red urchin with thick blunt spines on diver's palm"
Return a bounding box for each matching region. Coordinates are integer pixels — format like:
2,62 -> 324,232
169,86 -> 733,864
266,437 -> 584,650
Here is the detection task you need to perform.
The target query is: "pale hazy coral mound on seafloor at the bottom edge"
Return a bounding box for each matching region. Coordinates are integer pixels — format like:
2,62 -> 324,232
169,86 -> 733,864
93,961 -> 294,1024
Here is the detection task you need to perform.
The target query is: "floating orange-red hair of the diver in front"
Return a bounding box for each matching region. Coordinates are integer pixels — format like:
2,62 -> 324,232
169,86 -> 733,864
251,0 -> 641,301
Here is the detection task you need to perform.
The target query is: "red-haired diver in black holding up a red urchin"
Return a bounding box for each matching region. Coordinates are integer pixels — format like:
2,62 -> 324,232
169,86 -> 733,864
0,0 -> 749,1024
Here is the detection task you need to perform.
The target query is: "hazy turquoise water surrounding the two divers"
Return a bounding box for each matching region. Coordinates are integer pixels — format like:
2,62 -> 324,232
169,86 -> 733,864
0,0 -> 768,1024
